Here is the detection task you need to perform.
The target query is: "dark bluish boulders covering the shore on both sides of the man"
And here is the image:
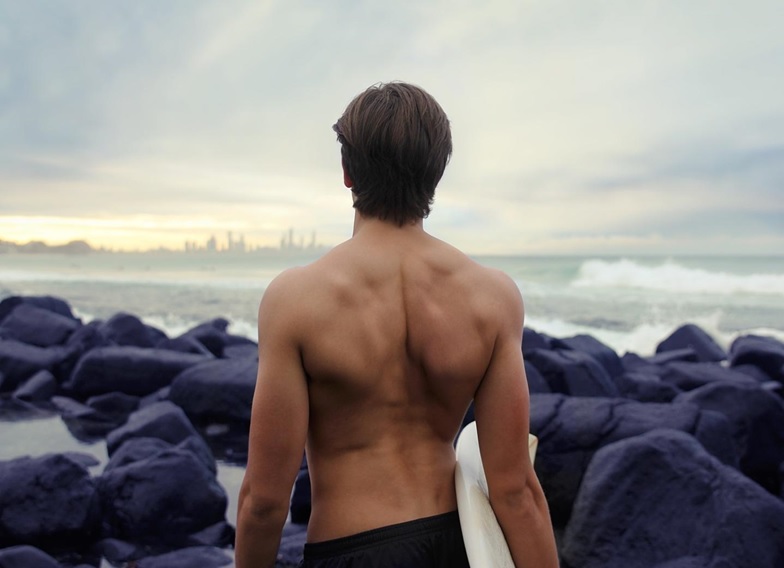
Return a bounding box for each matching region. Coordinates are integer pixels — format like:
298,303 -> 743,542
0,296 -> 784,568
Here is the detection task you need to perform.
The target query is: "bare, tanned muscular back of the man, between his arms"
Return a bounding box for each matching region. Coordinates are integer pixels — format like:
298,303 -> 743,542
290,225 -> 512,541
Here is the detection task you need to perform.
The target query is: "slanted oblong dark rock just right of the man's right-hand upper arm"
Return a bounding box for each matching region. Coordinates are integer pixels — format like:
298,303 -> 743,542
527,349 -> 620,397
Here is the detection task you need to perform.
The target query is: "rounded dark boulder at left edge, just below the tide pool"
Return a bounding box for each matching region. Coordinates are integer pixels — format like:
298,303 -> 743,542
0,454 -> 100,547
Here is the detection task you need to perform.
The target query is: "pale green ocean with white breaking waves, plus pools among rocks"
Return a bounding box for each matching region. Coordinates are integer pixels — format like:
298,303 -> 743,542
0,252 -> 784,560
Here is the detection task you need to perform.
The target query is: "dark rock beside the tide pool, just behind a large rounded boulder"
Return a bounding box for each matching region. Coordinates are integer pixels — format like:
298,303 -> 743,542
106,401 -> 198,456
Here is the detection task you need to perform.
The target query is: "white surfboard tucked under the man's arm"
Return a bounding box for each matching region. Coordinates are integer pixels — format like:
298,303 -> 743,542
455,422 -> 538,568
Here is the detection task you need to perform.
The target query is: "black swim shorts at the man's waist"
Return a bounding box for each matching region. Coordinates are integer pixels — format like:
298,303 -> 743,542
300,511 -> 468,568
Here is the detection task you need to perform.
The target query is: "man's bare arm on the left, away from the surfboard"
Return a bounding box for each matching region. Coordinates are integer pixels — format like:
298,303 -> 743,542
235,273 -> 309,568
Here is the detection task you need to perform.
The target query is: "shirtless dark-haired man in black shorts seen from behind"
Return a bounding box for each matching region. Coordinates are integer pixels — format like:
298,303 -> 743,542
236,83 -> 558,568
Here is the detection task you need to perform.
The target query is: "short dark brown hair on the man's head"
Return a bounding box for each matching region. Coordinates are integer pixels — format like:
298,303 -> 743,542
332,82 -> 452,226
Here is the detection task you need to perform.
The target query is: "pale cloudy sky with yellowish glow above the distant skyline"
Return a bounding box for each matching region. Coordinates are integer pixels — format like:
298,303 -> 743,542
0,0 -> 784,255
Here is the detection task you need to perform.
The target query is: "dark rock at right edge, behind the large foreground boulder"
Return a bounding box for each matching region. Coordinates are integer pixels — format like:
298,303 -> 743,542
675,382 -> 784,494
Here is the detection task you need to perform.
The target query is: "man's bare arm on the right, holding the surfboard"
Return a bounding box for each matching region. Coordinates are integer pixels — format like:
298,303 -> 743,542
474,276 -> 558,568
